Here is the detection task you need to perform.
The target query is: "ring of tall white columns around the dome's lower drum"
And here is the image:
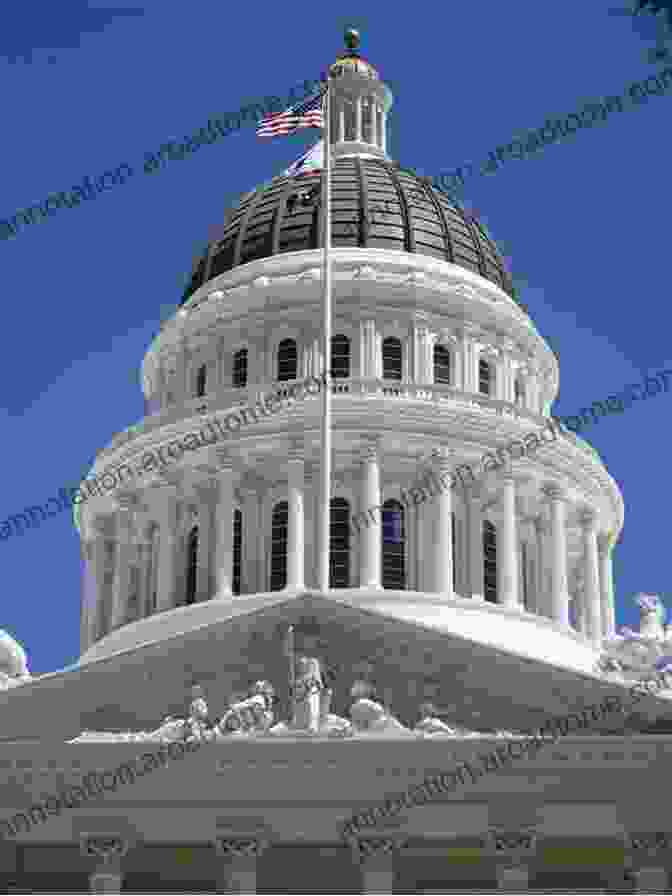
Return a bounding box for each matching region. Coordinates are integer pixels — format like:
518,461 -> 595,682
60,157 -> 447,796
82,438 -> 615,646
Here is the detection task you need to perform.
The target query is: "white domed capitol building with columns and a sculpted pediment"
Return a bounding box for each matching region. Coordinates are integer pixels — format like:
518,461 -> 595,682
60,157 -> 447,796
0,34 -> 672,893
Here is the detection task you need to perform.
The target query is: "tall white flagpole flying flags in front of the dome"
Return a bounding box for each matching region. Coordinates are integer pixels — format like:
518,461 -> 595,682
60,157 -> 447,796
318,77 -> 331,591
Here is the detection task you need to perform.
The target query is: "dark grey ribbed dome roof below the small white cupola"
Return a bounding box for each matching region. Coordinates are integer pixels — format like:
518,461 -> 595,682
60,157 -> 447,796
180,156 -> 515,304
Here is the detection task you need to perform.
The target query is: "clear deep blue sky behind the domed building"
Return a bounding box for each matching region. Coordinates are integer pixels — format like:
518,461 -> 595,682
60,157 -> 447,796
0,0 -> 672,672
